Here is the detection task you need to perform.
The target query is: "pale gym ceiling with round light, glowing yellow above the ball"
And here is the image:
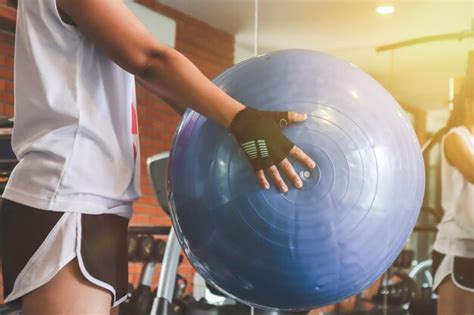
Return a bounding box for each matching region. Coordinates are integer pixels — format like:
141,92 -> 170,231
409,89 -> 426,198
159,0 -> 474,109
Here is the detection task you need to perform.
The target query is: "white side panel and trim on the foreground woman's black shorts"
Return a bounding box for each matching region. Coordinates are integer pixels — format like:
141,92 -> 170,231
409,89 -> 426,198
5,213 -> 127,307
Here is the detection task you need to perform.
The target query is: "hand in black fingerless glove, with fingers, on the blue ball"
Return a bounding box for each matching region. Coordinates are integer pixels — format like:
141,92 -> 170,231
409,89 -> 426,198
230,107 -> 316,192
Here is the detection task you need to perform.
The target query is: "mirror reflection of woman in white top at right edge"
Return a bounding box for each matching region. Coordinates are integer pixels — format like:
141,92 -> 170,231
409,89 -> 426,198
433,77 -> 474,315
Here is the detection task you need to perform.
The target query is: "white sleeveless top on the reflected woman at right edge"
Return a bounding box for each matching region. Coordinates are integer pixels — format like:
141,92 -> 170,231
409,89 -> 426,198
434,126 -> 474,257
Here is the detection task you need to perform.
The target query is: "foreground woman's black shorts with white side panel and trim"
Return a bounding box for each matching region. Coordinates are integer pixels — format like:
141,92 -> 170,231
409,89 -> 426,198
0,200 -> 128,307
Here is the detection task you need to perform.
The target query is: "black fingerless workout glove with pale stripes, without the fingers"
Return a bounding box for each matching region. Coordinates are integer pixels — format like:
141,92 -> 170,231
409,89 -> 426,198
230,107 -> 294,171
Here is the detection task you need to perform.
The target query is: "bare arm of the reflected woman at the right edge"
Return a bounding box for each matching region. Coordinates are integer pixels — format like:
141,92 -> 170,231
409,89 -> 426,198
444,133 -> 474,184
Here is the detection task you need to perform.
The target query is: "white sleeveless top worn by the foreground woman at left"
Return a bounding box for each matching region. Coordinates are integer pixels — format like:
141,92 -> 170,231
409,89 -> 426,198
3,0 -> 140,217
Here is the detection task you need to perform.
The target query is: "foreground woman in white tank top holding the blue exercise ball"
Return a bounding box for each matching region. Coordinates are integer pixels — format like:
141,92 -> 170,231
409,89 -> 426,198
2,0 -> 315,315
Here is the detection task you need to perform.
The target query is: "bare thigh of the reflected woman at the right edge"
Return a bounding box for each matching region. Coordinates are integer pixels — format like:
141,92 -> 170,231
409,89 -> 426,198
438,276 -> 474,315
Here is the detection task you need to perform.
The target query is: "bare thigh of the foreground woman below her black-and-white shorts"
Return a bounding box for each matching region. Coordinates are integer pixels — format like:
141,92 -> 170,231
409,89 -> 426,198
22,259 -> 113,315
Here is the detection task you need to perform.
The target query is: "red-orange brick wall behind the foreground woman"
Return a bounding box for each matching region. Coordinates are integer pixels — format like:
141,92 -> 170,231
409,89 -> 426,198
0,0 -> 234,302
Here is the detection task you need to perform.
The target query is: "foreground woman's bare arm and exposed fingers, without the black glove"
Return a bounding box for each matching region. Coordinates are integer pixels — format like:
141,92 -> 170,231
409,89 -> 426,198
57,0 -> 315,191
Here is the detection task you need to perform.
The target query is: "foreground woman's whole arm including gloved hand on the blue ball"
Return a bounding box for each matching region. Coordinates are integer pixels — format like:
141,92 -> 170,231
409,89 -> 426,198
57,0 -> 315,192
